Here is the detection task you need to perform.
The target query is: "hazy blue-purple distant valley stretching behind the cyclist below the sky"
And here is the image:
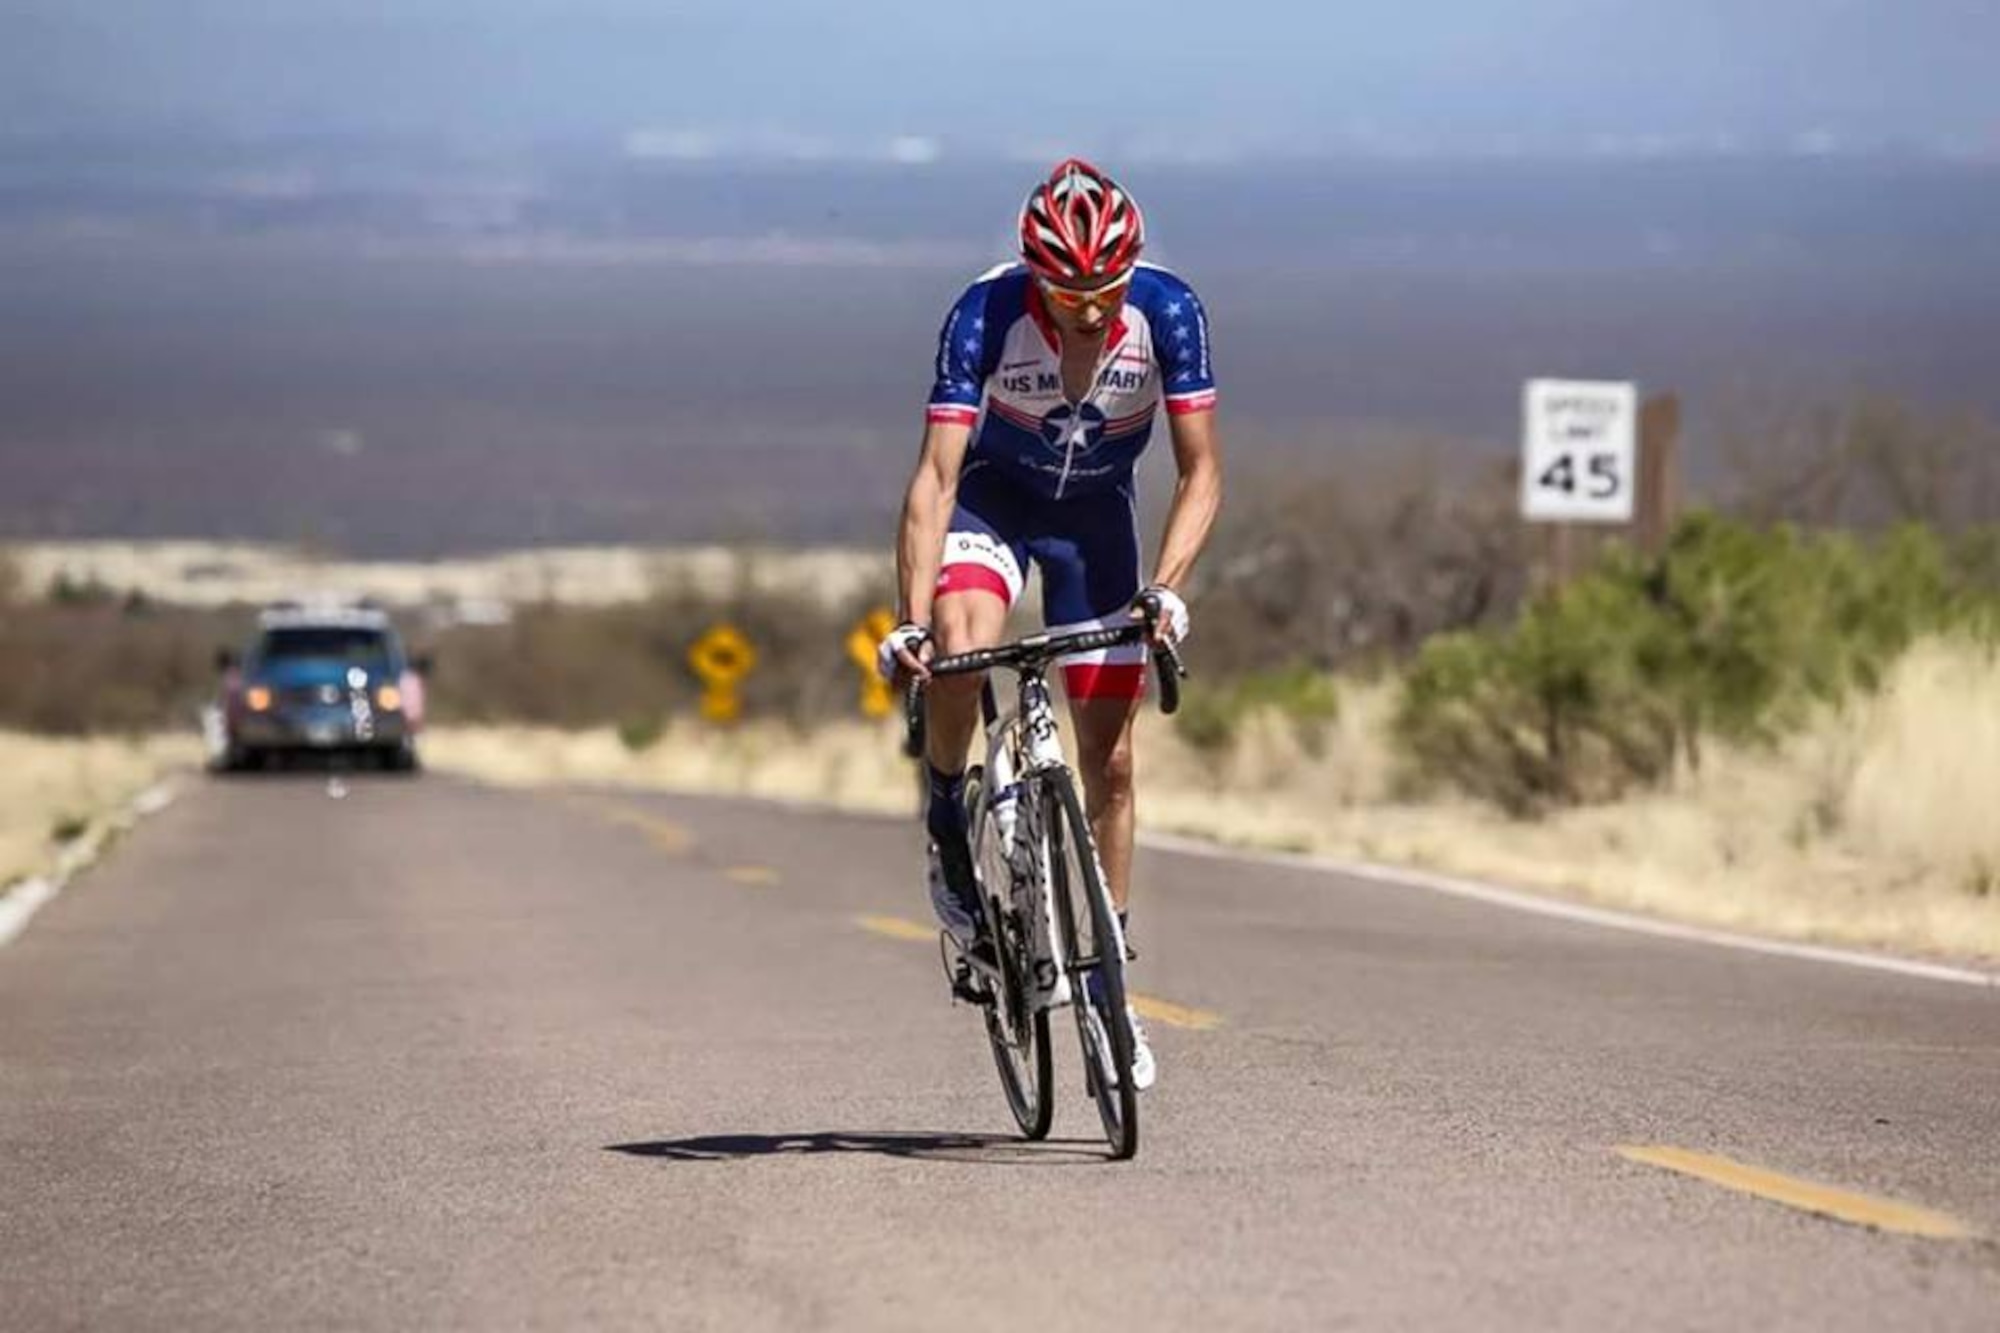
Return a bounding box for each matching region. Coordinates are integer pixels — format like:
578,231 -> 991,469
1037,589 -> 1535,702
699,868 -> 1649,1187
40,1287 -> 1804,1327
0,144 -> 2000,556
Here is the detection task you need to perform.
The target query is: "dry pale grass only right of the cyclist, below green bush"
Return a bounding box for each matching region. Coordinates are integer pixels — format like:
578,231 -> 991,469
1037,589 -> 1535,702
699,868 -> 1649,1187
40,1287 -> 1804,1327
1146,642 -> 2000,959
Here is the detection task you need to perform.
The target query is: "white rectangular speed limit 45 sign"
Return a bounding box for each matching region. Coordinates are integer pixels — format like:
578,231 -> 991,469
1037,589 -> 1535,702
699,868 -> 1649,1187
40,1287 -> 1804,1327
1520,380 -> 1638,522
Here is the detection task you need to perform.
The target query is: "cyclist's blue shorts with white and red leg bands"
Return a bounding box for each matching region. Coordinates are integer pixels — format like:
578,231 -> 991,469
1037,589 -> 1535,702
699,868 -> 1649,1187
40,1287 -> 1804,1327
938,460 -> 1146,699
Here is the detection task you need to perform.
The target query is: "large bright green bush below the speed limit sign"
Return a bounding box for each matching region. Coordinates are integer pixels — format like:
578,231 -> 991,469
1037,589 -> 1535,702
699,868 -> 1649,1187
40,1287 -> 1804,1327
1394,512 -> 1994,815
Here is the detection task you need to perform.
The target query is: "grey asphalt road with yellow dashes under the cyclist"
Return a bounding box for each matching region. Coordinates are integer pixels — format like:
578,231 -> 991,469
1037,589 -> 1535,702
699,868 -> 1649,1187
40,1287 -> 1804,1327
0,777 -> 2000,1331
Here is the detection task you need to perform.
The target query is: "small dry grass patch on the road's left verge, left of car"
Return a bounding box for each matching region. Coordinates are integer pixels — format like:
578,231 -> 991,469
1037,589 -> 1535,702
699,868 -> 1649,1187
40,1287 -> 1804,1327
0,733 -> 200,887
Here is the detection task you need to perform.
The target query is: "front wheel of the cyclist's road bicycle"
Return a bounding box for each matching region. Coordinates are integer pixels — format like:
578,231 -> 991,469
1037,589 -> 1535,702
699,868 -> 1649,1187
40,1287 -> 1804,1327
1042,771 -> 1138,1161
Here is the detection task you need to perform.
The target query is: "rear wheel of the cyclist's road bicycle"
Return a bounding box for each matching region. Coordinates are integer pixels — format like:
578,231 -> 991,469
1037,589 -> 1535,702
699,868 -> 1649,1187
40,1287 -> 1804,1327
966,769 -> 1056,1141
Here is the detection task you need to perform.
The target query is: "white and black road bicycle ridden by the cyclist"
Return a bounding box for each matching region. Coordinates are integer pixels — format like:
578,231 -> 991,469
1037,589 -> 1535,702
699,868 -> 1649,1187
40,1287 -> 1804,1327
908,598 -> 1186,1161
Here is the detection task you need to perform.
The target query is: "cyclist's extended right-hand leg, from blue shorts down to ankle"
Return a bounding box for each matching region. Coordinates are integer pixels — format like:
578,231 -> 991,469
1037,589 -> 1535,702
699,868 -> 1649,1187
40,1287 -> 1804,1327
1030,490 -> 1146,915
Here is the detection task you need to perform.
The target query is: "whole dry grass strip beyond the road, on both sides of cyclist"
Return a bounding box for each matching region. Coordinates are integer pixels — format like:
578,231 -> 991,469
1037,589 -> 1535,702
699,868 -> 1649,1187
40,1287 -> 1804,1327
430,642 -> 2000,959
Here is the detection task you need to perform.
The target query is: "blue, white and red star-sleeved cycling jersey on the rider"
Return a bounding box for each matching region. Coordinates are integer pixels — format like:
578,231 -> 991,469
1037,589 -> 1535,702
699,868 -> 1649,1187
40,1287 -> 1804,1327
928,264 -> 1216,498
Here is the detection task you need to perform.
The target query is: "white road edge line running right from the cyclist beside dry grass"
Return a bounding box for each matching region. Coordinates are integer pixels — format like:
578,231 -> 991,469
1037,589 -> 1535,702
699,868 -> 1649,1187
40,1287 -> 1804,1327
1140,833 -> 2000,989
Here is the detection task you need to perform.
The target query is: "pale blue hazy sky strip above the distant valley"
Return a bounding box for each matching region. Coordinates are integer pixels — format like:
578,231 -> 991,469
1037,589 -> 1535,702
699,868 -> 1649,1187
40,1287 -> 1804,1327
0,0 -> 2000,154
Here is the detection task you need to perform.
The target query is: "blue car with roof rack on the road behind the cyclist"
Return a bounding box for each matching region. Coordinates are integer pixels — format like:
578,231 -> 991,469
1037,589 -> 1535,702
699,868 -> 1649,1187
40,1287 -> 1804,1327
214,604 -> 426,773
